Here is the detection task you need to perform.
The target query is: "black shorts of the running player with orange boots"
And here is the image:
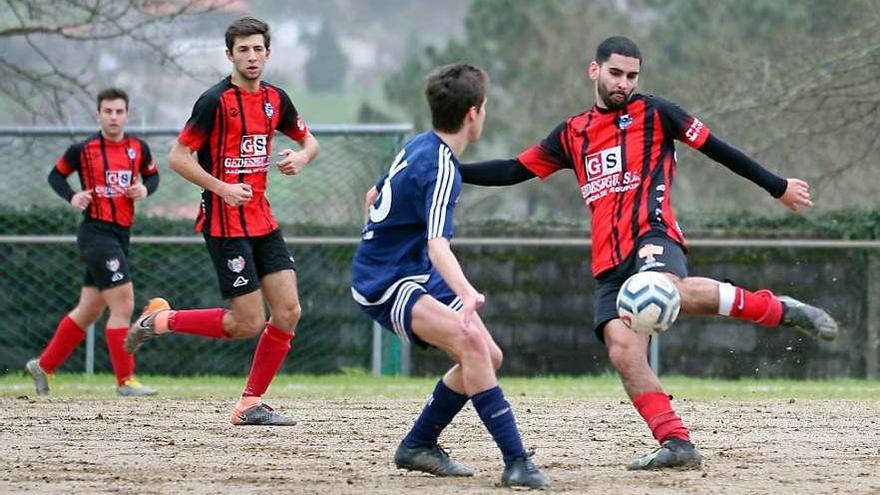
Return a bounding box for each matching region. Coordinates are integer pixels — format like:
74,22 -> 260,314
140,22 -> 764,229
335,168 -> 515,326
205,229 -> 296,299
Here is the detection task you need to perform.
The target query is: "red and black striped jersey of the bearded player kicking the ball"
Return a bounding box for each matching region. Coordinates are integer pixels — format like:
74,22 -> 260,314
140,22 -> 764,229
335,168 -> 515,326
517,94 -> 710,276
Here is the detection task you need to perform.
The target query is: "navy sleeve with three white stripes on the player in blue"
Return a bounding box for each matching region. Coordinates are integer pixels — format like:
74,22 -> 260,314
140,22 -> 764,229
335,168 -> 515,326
423,146 -> 459,239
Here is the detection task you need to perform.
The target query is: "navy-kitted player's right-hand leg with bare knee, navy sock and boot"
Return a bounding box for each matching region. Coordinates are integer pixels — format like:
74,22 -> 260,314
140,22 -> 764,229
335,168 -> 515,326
411,295 -> 547,487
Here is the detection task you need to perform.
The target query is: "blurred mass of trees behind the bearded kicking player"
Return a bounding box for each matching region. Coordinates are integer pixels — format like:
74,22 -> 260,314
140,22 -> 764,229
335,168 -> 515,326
385,0 -> 880,221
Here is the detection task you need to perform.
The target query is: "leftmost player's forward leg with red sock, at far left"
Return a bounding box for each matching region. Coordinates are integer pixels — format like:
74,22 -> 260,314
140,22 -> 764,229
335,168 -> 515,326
25,286 -> 105,395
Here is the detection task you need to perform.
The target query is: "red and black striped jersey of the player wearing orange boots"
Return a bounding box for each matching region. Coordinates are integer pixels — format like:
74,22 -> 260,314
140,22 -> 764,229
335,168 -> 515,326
177,77 -> 308,237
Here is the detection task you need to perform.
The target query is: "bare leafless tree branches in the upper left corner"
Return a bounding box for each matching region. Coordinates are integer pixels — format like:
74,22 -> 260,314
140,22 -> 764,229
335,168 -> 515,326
0,0 -> 233,122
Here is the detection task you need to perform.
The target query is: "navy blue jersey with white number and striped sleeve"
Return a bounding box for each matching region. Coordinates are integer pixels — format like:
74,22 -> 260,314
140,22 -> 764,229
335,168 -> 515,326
352,131 -> 461,306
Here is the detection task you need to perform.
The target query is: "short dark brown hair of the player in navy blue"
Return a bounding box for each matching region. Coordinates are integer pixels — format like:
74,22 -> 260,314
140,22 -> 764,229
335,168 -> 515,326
425,63 -> 489,132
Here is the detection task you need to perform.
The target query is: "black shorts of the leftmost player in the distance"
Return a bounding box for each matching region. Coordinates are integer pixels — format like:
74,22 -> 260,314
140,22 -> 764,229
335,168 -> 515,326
76,219 -> 131,290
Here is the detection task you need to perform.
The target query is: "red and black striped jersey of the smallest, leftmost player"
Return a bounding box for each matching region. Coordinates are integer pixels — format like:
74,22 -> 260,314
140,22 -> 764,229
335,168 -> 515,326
55,132 -> 159,227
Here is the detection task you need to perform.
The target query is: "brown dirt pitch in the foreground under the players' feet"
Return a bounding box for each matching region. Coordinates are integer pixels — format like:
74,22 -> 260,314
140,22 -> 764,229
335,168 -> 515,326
0,397 -> 880,495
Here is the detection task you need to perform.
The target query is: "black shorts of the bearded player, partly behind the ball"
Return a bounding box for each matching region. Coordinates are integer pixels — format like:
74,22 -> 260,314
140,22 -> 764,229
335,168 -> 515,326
593,232 -> 687,344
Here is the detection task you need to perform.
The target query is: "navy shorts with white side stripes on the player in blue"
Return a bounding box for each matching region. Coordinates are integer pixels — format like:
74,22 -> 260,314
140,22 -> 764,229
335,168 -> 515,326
352,270 -> 461,347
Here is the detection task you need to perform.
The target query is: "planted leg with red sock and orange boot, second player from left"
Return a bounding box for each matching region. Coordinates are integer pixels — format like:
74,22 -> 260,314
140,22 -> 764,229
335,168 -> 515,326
232,270 -> 301,425
